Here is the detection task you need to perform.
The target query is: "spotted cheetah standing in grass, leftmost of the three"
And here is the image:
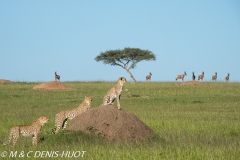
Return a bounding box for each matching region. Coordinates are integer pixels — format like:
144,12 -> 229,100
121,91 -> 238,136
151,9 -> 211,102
3,117 -> 48,146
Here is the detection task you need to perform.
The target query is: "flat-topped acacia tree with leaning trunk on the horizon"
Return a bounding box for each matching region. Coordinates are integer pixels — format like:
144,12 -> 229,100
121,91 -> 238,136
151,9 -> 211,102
95,48 -> 156,82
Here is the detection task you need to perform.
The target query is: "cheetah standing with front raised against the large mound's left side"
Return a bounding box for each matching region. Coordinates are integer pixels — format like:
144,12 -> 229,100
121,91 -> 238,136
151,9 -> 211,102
52,96 -> 92,134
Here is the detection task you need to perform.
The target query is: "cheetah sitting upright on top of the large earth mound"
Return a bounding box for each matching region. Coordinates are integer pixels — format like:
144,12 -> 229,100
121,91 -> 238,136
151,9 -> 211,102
103,77 -> 127,109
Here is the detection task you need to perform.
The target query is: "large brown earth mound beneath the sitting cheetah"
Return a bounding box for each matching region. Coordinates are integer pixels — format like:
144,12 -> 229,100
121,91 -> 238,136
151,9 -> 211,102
67,105 -> 154,142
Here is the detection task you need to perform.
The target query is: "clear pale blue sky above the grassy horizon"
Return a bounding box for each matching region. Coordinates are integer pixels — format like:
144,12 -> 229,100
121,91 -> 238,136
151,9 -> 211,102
0,0 -> 240,82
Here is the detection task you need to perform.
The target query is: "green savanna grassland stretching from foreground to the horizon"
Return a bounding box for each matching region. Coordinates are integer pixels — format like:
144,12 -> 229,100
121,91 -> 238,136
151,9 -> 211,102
0,82 -> 240,160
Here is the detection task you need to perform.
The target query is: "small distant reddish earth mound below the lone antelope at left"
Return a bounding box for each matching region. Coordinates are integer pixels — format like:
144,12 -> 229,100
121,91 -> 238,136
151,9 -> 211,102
33,81 -> 70,90
